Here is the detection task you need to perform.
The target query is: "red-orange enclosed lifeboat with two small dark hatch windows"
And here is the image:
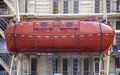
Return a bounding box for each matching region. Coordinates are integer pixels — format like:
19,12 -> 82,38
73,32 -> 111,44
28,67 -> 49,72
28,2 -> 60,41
4,17 -> 114,54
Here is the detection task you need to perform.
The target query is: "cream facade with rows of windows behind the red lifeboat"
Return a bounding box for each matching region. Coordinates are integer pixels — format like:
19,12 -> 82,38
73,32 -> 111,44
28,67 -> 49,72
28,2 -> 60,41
0,0 -> 120,75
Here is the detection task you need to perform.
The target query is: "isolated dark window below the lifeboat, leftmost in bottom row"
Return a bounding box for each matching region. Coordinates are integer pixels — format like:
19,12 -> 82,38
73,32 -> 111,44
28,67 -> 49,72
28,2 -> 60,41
31,58 -> 37,75
